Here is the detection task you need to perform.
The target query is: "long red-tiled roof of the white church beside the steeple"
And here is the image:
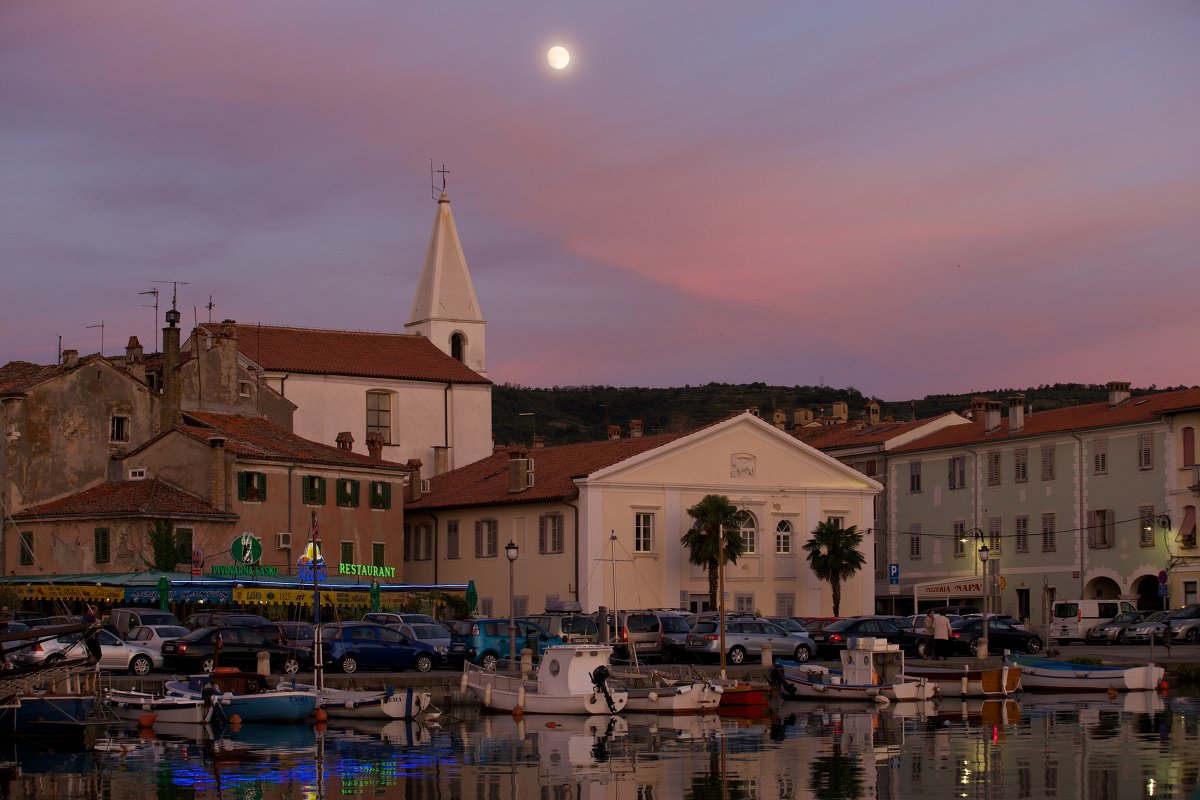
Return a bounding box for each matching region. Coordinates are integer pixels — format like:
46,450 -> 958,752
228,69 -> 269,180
200,323 -> 491,384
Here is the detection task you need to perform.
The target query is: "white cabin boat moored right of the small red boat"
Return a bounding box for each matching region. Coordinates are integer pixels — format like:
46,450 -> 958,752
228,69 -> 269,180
772,637 -> 938,704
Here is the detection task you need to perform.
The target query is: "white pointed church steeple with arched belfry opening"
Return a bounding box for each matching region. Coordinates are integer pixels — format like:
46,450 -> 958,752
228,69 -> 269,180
404,190 -> 487,375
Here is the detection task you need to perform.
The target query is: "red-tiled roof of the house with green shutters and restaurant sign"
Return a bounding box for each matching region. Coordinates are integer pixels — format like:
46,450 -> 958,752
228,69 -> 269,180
175,411 -> 408,471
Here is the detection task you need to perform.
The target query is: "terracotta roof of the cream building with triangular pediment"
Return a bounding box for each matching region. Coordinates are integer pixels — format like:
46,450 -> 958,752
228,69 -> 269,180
404,431 -> 695,511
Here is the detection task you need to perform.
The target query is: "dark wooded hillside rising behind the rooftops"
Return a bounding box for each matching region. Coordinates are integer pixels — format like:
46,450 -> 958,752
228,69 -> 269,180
492,384 -> 1183,445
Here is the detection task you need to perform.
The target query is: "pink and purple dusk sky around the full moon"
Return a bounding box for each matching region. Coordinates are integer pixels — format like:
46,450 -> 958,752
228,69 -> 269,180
0,0 -> 1200,401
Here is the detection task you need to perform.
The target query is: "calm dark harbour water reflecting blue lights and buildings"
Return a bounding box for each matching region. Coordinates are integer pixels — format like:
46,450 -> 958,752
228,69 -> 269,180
0,693 -> 1200,800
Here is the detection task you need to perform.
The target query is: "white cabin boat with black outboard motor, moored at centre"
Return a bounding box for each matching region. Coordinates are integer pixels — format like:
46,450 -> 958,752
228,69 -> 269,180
461,644 -> 629,715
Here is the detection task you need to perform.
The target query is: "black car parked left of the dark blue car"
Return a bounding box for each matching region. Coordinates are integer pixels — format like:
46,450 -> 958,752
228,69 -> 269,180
162,626 -> 312,675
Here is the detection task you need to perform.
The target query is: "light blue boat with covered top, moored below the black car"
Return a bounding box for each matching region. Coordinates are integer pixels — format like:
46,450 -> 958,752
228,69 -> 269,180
164,669 -> 317,722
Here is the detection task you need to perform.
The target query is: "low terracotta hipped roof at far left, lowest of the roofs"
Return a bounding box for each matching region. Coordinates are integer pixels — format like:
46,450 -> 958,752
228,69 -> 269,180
13,477 -> 238,519
